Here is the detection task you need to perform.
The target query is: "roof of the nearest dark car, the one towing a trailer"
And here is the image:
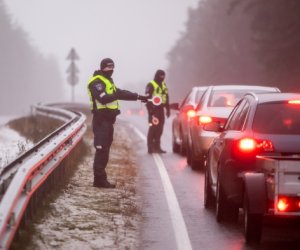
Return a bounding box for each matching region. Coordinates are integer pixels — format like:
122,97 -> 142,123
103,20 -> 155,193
246,93 -> 300,103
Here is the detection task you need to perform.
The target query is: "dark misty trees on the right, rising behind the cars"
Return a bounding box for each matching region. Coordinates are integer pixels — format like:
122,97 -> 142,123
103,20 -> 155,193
168,0 -> 300,100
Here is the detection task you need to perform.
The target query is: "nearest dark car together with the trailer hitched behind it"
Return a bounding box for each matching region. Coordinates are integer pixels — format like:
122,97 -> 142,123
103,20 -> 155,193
203,93 -> 300,242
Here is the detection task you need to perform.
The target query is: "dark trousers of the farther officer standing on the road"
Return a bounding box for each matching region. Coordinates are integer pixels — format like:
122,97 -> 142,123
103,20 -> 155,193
147,108 -> 165,150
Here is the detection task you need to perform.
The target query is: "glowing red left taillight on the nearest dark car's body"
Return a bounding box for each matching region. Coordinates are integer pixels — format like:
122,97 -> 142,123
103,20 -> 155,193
237,138 -> 274,153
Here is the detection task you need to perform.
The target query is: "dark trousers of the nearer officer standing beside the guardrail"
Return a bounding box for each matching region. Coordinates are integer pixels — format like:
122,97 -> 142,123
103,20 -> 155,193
93,116 -> 114,185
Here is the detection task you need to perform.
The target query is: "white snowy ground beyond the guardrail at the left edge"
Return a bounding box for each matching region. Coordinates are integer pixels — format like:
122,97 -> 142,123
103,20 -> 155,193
0,116 -> 33,167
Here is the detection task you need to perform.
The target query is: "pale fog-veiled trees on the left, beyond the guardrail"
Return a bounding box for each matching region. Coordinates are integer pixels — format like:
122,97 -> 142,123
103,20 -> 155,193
0,0 -> 63,115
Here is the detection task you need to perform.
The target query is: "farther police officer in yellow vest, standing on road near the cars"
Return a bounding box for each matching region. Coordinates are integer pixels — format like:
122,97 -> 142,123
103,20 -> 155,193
146,69 -> 170,154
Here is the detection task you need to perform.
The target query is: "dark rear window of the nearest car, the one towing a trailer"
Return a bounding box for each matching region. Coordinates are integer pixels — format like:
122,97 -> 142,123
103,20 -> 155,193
253,103 -> 300,135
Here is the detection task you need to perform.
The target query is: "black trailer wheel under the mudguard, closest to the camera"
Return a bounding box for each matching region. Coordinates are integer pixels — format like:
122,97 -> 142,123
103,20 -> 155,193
244,192 -> 263,243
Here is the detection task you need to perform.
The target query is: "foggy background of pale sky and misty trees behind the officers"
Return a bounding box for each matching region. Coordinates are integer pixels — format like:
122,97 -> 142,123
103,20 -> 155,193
0,0 -> 300,112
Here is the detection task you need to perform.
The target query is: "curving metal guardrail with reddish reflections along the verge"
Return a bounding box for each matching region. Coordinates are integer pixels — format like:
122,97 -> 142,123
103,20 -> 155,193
0,103 -> 86,249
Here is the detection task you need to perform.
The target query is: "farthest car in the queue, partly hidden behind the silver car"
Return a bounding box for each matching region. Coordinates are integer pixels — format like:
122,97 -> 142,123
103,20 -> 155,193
172,86 -> 207,155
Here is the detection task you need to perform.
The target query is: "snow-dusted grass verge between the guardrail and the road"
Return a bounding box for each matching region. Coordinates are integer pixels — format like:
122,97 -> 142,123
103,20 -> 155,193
26,124 -> 141,250
